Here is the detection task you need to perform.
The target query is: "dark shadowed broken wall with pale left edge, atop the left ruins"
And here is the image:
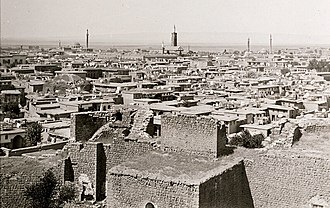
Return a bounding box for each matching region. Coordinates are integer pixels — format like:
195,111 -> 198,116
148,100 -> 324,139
70,112 -> 110,142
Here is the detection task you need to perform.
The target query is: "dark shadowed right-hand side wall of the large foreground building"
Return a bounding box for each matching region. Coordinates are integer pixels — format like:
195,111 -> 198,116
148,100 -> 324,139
199,161 -> 254,208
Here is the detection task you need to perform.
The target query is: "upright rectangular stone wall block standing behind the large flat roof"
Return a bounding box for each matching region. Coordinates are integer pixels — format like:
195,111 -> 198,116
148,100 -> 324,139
161,114 -> 226,157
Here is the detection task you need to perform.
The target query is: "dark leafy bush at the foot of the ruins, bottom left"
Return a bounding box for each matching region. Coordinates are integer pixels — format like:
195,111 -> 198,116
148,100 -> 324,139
24,170 -> 75,208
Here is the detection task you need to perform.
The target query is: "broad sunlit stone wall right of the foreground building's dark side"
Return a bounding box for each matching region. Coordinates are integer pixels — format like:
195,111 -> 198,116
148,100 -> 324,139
245,153 -> 330,208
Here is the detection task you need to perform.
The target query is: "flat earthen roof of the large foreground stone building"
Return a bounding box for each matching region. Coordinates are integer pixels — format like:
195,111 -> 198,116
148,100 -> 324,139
109,151 -> 242,185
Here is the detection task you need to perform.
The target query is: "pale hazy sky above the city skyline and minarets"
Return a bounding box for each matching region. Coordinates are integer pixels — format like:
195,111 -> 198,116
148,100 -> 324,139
0,0 -> 330,44
